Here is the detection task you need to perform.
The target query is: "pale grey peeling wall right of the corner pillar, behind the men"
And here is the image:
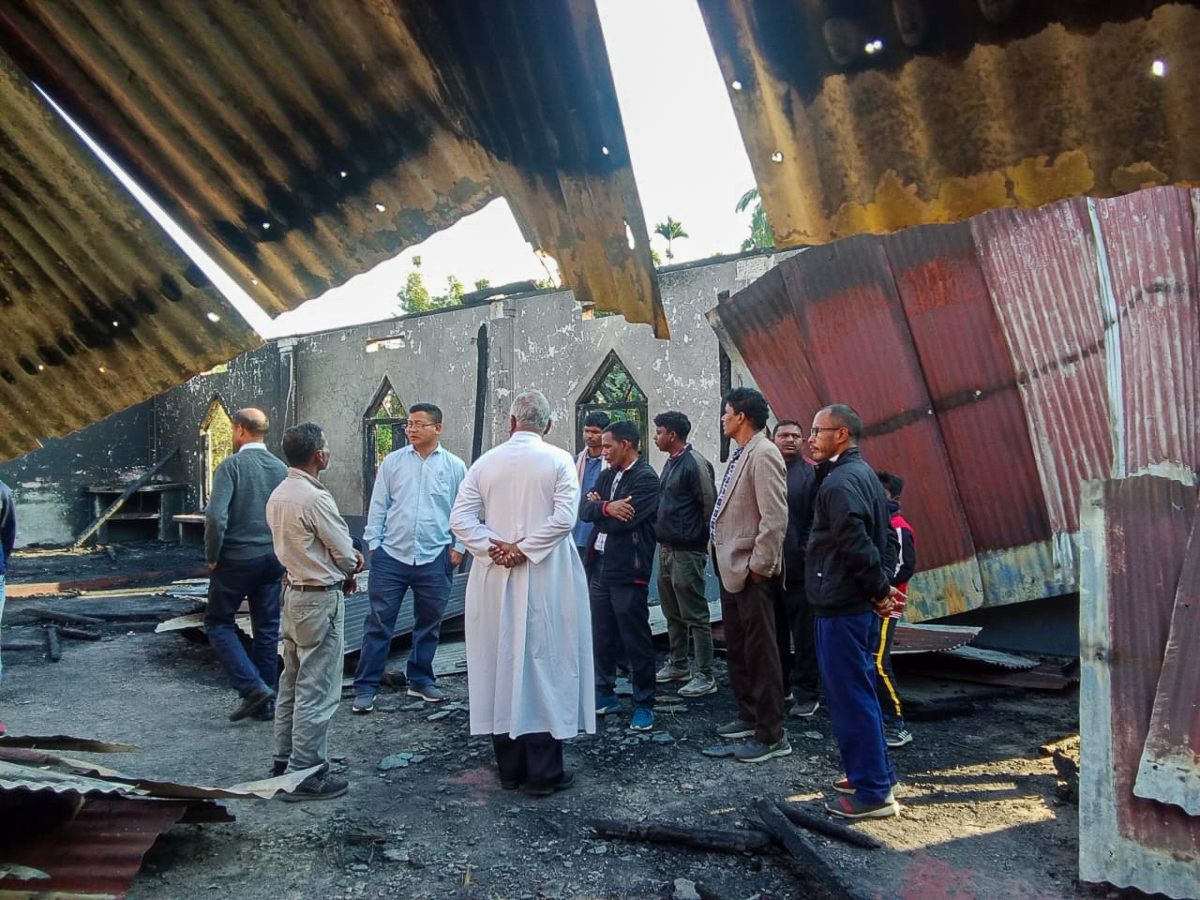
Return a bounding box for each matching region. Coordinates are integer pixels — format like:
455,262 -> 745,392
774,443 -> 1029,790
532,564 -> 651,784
285,256 -> 774,520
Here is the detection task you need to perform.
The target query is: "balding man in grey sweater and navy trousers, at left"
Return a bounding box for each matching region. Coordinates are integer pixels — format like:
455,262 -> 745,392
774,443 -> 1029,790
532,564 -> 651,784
204,409 -> 288,721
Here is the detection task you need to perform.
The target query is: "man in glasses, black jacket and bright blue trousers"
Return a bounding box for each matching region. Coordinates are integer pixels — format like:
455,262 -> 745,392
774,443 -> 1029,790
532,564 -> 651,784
805,403 -> 900,818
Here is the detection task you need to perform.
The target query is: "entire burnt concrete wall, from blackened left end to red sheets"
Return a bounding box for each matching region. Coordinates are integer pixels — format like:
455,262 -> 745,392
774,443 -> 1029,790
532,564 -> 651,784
0,254 -> 782,544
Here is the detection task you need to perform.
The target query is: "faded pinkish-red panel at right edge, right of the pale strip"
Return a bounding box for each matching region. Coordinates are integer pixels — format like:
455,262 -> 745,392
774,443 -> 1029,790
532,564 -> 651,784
1096,187 -> 1200,474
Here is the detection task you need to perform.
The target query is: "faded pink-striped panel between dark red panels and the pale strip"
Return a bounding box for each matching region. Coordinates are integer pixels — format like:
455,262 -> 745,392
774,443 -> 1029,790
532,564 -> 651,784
971,200 -> 1112,540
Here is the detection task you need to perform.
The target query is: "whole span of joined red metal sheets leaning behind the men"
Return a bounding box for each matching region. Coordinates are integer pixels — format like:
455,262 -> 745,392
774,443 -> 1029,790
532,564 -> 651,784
710,187 -> 1200,619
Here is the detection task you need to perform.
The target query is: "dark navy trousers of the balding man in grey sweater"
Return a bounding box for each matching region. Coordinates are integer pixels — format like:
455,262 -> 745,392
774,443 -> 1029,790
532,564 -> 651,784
204,553 -> 283,697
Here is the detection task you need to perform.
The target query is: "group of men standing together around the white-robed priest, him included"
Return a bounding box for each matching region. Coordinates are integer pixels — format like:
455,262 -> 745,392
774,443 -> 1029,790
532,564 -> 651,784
199,388 -> 899,817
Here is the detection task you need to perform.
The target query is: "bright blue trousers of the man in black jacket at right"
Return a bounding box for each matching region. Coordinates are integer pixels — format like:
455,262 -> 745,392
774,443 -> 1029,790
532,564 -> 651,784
816,612 -> 896,804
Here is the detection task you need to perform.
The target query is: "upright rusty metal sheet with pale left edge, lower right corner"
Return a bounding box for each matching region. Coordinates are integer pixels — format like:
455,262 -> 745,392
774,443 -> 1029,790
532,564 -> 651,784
1079,475 -> 1200,898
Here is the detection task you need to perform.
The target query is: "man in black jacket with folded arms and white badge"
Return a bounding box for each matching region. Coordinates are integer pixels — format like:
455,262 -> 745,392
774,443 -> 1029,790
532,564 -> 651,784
580,420 -> 659,731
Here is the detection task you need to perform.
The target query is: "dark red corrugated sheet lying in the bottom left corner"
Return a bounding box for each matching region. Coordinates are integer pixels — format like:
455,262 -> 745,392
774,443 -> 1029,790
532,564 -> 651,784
0,798 -> 187,899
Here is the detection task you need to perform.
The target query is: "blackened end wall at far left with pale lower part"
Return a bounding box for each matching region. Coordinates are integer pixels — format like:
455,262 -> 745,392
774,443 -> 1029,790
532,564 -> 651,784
0,401 -> 155,547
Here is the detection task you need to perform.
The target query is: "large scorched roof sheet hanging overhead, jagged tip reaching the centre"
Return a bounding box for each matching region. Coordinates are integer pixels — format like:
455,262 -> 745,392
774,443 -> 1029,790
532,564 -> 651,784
0,0 -> 667,337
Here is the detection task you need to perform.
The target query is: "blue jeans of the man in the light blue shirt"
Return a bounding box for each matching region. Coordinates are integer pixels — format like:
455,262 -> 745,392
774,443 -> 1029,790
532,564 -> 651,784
354,546 -> 454,696
